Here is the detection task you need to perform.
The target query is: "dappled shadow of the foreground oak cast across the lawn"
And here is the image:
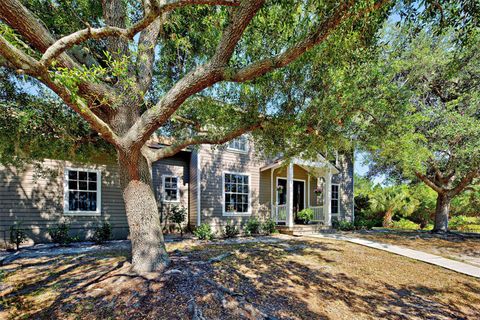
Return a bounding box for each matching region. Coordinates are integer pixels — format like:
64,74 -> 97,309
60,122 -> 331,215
1,241 -> 480,319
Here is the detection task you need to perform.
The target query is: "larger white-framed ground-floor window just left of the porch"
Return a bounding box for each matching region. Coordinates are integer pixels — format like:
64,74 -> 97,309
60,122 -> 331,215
223,173 -> 250,214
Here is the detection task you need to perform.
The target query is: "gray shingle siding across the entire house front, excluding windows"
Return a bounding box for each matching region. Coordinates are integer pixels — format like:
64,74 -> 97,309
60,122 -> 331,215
0,142 -> 354,242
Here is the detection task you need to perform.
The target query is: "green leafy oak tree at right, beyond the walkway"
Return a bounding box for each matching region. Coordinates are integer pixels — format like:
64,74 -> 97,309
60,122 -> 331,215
354,26 -> 480,232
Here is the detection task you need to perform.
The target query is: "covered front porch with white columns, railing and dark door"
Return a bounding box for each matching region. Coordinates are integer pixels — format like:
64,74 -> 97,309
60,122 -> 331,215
261,158 -> 339,228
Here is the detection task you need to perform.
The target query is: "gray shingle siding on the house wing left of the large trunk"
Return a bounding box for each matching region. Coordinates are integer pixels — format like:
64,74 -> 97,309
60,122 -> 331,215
0,160 -> 128,242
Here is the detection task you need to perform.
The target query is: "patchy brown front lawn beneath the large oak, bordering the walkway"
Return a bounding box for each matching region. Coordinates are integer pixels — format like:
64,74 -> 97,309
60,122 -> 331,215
0,236 -> 480,319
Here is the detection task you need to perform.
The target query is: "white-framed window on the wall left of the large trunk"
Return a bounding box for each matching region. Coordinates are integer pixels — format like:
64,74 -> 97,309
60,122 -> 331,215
64,168 -> 100,214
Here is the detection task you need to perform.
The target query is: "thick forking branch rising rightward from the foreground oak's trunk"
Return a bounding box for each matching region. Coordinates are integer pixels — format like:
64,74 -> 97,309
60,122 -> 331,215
125,0 -> 390,148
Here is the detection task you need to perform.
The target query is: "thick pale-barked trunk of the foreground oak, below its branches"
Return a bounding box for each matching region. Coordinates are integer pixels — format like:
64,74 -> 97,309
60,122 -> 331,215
119,154 -> 169,273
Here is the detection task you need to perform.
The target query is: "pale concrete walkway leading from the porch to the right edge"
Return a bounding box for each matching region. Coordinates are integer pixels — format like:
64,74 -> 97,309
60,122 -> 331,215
303,234 -> 480,278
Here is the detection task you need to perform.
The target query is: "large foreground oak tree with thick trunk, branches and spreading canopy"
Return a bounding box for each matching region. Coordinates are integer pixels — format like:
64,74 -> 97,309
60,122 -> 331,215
0,0 -> 468,271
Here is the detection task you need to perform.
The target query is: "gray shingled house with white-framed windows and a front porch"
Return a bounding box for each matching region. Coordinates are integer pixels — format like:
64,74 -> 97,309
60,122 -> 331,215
0,136 -> 354,242
